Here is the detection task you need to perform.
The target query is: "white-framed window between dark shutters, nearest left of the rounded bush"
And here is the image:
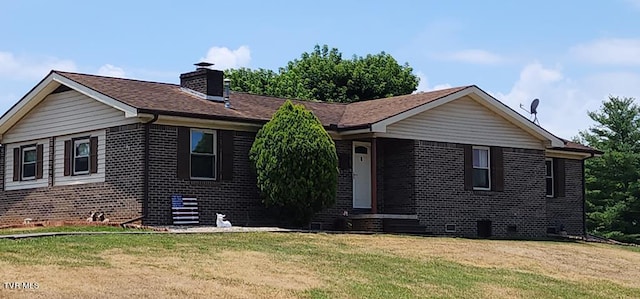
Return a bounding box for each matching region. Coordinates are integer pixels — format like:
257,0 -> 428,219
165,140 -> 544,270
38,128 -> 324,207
190,129 -> 216,179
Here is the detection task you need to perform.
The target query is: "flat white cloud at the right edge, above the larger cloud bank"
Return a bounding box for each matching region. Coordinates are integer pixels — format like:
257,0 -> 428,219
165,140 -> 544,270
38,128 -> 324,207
570,38 -> 640,65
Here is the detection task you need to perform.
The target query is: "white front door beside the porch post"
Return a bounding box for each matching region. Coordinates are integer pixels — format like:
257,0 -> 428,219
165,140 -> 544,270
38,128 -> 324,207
353,141 -> 371,209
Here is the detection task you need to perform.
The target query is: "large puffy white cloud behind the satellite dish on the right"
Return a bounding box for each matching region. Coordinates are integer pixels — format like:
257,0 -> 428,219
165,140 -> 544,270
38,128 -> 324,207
495,62 -> 640,139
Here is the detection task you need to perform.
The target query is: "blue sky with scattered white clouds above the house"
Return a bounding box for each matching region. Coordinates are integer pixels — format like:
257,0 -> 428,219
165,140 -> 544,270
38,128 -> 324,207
0,0 -> 640,138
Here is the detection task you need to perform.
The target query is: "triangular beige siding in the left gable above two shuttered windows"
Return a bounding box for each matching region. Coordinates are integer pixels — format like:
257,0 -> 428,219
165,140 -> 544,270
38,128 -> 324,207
2,90 -> 139,144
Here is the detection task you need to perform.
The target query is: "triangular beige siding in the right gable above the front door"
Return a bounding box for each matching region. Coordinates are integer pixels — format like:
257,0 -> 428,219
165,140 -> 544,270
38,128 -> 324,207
379,97 -> 544,149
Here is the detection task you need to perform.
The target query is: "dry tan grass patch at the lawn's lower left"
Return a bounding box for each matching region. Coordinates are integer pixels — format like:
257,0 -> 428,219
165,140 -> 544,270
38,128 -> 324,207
0,251 -> 322,298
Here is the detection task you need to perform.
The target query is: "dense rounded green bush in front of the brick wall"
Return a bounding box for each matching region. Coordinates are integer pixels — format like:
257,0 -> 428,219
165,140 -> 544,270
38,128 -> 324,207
249,101 -> 338,225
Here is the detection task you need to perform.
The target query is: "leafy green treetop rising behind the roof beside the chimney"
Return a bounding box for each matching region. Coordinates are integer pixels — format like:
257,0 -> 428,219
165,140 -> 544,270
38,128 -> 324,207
225,45 -> 419,102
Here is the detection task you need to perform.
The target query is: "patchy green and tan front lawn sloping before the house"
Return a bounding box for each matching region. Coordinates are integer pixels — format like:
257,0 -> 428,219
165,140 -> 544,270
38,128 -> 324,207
0,233 -> 640,298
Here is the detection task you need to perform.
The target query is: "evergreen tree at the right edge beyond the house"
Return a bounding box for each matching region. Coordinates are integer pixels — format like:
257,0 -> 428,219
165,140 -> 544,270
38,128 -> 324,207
580,96 -> 640,241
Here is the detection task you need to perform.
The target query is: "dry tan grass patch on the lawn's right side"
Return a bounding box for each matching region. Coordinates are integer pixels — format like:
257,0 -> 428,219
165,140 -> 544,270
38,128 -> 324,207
336,235 -> 640,287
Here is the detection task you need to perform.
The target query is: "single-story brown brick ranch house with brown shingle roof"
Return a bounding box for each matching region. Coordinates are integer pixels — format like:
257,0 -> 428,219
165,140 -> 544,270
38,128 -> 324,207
0,66 -> 601,237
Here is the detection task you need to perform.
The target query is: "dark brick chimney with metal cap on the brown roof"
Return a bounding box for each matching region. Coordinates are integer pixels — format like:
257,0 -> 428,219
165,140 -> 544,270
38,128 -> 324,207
180,62 -> 224,101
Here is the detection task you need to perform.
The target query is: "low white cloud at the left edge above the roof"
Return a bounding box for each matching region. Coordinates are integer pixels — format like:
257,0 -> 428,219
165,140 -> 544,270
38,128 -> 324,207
0,51 -> 77,79
